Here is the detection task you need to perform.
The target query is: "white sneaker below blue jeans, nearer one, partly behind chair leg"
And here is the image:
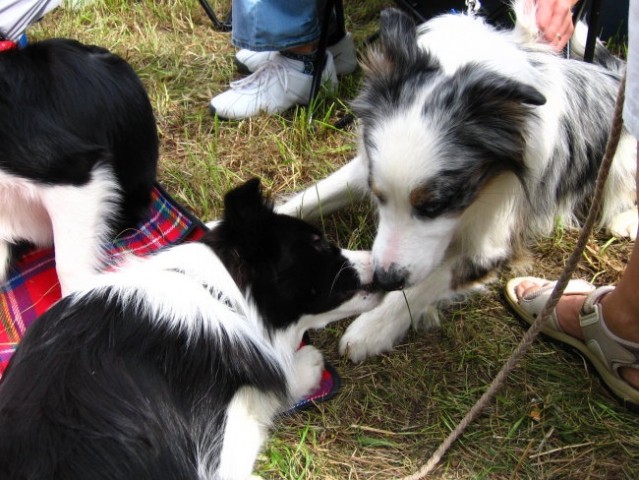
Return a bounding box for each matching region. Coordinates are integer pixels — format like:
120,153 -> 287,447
209,52 -> 337,120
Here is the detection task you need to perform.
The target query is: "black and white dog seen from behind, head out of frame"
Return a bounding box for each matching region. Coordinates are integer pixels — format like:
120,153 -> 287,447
0,39 -> 158,295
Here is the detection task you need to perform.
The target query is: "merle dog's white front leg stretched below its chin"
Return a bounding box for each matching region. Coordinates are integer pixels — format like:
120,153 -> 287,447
339,266 -> 453,363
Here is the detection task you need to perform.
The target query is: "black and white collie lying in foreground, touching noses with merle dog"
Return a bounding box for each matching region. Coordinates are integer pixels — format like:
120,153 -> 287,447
0,180 -> 382,480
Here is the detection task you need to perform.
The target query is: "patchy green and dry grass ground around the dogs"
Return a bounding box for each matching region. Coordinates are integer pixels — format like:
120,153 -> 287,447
29,0 -> 639,479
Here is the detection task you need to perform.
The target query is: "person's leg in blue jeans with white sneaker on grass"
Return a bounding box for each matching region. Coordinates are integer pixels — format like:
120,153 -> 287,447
209,0 -> 337,120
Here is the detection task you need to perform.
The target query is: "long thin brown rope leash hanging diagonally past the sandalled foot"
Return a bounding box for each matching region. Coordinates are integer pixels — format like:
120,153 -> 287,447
402,71 -> 626,480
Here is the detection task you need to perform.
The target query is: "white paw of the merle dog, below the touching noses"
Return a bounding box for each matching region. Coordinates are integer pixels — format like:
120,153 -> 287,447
339,308 -> 410,363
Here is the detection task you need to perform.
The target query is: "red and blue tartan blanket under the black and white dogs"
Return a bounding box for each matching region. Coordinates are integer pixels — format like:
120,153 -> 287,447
0,185 -> 339,409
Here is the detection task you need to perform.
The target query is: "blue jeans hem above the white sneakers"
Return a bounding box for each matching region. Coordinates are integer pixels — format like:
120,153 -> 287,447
231,0 -> 320,52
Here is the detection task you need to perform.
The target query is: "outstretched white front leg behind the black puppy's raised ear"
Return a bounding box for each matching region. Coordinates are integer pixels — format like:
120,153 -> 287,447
275,156 -> 368,221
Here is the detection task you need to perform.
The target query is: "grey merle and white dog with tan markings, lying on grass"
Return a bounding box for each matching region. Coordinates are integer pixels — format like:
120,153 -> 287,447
278,0 -> 637,361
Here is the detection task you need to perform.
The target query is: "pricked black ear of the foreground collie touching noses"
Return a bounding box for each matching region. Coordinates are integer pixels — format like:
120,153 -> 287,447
224,178 -> 273,228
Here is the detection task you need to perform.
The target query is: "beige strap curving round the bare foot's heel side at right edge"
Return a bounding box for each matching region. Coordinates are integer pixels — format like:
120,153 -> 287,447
579,286 -> 639,378
